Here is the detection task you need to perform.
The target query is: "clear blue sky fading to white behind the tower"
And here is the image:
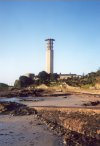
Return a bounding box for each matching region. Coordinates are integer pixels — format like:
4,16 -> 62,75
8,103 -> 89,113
0,0 -> 100,85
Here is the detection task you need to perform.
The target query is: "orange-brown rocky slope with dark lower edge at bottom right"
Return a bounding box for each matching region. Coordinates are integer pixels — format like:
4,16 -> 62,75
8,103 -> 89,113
36,108 -> 100,146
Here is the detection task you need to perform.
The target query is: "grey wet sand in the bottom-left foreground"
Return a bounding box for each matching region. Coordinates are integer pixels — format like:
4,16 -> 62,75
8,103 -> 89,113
0,115 -> 63,146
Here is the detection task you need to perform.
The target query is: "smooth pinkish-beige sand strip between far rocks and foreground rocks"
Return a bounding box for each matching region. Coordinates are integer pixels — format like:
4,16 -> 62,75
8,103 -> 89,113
21,95 -> 100,108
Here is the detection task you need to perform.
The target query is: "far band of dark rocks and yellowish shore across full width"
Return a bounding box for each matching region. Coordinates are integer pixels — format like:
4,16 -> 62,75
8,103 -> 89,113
0,87 -> 100,98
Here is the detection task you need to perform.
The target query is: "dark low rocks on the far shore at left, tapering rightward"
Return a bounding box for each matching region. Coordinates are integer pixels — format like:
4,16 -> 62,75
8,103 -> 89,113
0,88 -> 71,98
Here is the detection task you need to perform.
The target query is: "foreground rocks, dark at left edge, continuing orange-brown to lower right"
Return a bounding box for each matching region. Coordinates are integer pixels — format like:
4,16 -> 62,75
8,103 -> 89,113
0,102 -> 100,146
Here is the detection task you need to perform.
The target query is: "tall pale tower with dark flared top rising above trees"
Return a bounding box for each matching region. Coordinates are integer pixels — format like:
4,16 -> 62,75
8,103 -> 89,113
45,38 -> 55,74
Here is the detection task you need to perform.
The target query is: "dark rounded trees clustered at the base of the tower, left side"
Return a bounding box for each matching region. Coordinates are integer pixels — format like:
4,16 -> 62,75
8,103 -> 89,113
14,71 -> 59,88
